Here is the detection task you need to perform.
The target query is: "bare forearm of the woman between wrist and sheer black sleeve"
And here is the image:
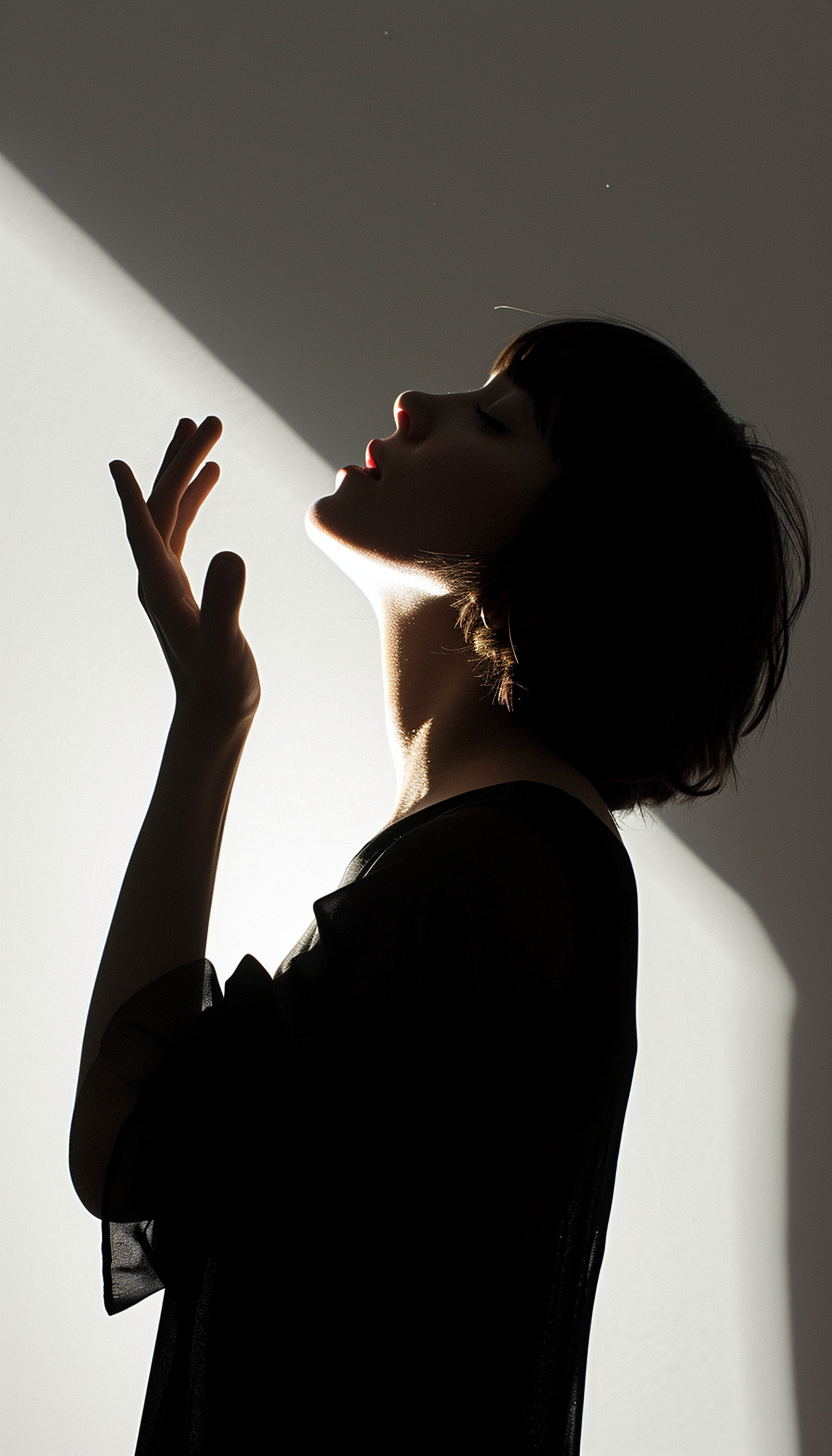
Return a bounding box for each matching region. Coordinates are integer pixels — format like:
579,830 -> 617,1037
79,701 -> 251,1088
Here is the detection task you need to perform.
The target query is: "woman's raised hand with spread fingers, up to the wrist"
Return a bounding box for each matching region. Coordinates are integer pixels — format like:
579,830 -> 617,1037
109,415 -> 259,728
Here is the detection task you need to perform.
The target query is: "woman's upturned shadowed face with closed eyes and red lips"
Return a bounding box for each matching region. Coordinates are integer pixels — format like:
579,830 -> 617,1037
306,374 -> 558,565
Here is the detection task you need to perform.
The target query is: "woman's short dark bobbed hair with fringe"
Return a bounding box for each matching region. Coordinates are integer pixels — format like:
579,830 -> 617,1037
420,317 -> 810,810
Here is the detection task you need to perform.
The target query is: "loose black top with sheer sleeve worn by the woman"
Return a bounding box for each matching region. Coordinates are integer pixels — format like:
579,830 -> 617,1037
101,782 -> 638,1456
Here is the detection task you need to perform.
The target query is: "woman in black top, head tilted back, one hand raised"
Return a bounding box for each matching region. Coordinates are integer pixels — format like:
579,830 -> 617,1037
70,319 -> 809,1456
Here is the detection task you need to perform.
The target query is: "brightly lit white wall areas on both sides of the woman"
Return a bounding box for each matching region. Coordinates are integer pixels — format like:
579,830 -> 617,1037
0,153 -> 797,1456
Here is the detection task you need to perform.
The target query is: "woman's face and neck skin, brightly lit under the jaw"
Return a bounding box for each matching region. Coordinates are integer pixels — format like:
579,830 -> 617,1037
306,374 -> 621,837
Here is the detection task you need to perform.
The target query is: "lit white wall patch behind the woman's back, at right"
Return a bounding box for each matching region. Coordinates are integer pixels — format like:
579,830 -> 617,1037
583,815 -> 798,1456
